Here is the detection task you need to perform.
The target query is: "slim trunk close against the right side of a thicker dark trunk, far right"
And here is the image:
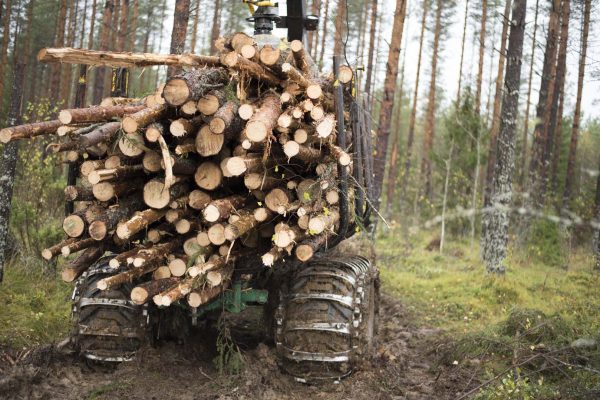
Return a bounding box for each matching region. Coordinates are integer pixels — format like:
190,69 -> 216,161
546,0 -> 571,193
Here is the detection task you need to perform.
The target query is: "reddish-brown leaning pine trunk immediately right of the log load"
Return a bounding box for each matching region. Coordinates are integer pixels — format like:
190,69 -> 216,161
374,0 -> 406,208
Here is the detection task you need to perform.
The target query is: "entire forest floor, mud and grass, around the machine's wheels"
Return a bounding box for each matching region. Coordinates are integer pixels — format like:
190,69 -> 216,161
0,227 -> 600,400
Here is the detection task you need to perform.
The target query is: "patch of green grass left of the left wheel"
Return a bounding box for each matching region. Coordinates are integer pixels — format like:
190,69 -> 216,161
0,258 -> 73,348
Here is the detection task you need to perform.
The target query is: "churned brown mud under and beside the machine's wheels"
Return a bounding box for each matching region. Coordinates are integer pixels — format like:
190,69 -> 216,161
0,296 -> 475,400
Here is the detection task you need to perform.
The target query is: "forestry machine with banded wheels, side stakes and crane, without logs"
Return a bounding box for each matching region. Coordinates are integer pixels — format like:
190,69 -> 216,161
71,0 -> 379,382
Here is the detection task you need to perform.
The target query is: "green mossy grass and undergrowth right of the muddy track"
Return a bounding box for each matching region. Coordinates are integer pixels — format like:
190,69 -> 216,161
377,226 -> 600,400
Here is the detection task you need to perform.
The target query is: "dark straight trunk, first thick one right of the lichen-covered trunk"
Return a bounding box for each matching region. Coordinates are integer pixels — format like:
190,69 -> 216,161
529,0 -> 560,206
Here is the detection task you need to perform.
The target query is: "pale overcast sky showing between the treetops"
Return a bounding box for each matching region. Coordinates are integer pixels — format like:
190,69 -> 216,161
161,0 -> 600,118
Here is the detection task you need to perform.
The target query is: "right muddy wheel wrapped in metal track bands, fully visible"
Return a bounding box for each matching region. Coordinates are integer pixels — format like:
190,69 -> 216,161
275,257 -> 379,382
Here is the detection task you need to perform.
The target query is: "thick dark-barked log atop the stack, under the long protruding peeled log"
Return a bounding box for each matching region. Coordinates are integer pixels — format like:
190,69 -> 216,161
162,68 -> 229,107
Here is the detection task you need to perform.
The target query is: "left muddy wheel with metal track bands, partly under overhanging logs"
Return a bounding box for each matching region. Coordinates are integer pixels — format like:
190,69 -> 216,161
72,258 -> 147,362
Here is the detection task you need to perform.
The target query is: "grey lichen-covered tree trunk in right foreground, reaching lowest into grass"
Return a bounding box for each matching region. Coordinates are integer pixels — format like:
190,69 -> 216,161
482,0 -> 527,274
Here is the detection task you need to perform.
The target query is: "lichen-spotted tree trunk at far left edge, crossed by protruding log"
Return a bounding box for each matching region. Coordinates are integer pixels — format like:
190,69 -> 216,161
0,61 -> 25,282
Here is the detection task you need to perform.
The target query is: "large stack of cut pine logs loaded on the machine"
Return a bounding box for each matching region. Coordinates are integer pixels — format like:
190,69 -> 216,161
0,33 -> 352,307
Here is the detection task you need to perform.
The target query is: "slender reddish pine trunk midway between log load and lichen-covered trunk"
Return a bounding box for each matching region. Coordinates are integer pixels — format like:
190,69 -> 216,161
421,0 -> 443,199
